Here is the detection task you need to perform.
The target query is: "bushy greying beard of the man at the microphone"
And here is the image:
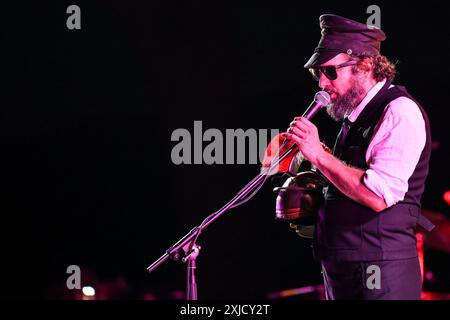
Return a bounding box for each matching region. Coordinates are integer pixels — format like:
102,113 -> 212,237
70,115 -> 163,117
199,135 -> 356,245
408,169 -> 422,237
327,78 -> 367,121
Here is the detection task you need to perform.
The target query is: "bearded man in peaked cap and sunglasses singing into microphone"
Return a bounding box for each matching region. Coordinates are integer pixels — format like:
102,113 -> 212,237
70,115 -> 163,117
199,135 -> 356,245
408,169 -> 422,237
283,14 -> 433,299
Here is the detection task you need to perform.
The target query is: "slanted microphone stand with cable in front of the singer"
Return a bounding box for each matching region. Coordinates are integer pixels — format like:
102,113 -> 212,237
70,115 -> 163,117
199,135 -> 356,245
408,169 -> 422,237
147,140 -> 296,300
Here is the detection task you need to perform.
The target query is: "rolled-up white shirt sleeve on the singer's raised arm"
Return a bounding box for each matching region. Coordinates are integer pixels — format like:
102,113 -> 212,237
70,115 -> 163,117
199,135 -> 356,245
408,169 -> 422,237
363,97 -> 426,207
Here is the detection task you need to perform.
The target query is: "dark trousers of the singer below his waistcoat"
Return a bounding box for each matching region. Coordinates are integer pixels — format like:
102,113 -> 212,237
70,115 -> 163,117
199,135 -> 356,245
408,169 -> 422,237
322,257 -> 422,300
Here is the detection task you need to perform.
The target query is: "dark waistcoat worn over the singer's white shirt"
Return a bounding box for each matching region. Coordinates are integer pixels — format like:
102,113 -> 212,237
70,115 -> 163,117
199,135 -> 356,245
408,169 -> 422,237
313,81 -> 433,261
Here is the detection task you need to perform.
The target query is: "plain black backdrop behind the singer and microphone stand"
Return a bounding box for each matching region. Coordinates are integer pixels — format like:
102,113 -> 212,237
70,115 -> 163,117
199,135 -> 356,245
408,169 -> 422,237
4,0 -> 450,299
